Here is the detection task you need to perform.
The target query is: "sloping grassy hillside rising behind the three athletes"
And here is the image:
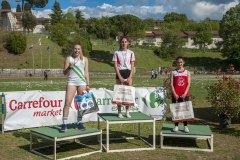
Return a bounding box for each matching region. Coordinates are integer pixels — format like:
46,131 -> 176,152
0,34 -> 232,73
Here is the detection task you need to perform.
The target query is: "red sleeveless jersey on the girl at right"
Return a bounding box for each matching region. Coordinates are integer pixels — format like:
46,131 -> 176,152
172,69 -> 189,96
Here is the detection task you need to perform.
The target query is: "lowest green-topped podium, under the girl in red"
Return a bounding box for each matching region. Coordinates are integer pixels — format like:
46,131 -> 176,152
160,124 -> 213,152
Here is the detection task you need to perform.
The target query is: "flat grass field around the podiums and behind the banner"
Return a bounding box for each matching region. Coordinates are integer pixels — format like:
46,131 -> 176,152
0,76 -> 240,160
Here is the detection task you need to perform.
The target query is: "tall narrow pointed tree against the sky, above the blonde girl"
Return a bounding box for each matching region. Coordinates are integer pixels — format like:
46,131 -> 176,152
49,1 -> 63,25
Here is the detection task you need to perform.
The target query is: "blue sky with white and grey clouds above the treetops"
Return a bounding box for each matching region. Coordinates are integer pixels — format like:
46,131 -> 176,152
5,0 -> 240,20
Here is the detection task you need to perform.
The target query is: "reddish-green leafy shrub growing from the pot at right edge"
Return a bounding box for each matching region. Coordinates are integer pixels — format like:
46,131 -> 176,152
207,76 -> 240,118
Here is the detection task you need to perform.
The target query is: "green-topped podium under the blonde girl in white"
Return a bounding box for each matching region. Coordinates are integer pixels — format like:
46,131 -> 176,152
30,125 -> 102,160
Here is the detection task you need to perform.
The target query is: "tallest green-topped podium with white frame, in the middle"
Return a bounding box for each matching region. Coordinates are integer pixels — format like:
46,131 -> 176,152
98,112 -> 156,152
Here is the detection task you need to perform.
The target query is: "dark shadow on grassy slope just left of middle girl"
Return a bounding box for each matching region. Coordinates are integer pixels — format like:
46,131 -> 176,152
90,50 -> 113,67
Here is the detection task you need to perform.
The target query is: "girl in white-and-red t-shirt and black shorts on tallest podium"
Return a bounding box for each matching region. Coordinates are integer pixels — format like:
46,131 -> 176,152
113,36 -> 135,118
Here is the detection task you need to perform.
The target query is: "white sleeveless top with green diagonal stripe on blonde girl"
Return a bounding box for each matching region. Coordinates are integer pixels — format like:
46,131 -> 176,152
68,56 -> 86,86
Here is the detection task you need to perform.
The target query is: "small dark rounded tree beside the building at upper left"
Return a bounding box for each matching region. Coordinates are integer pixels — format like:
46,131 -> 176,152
22,12 -> 37,32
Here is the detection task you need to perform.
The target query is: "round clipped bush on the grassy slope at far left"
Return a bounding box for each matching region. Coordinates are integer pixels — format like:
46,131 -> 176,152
6,32 -> 27,54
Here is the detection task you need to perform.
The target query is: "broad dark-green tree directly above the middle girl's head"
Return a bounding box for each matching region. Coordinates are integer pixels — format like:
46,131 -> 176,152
110,14 -> 144,36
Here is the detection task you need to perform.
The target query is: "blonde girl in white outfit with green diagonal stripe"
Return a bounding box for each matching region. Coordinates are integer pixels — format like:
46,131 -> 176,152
60,44 -> 89,132
